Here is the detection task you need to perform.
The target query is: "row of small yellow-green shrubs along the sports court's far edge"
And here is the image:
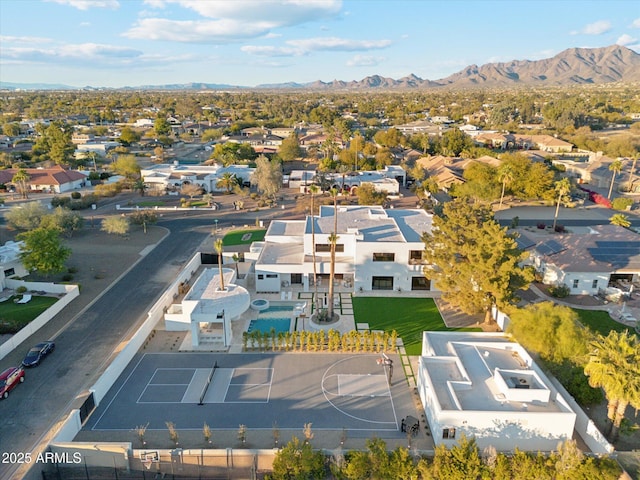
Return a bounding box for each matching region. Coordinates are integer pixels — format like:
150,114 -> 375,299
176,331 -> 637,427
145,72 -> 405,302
242,328 -> 398,353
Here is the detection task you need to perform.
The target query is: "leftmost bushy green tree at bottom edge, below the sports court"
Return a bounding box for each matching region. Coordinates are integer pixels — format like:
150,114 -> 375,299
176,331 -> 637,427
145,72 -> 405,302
269,437 -> 326,480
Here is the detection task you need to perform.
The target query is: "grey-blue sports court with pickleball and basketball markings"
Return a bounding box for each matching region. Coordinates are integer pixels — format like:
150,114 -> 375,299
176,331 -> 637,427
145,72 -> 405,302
85,353 -> 415,435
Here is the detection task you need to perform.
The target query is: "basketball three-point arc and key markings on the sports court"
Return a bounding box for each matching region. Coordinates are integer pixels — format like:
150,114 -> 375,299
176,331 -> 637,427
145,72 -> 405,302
320,355 -> 397,428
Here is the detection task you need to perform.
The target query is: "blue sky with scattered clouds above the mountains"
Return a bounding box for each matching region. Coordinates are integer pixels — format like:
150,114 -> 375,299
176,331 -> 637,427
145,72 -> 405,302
0,0 -> 640,87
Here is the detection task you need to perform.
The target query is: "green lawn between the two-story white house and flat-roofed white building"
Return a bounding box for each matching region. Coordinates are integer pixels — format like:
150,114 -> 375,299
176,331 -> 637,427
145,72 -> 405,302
353,297 -> 482,355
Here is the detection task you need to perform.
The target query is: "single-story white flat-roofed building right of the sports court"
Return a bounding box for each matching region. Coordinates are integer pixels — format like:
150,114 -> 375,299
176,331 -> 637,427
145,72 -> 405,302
418,332 -> 576,452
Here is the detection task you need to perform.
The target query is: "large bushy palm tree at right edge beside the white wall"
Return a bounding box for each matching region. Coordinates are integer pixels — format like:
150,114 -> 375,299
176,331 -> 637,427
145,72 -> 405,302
584,330 -> 640,441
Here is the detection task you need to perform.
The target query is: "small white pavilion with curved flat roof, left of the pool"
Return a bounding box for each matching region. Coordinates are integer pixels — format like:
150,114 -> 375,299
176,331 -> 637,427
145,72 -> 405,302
164,267 -> 251,347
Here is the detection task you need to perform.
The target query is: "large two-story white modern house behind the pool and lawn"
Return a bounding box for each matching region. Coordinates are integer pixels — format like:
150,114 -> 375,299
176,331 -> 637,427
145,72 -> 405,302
252,205 -> 432,292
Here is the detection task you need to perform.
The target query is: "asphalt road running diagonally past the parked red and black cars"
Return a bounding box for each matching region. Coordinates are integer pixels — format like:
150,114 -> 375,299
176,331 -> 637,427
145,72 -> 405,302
0,217 -> 212,479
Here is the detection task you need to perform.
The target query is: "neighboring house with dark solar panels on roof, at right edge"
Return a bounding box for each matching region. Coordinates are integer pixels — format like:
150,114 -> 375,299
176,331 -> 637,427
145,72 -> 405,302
518,225 -> 640,295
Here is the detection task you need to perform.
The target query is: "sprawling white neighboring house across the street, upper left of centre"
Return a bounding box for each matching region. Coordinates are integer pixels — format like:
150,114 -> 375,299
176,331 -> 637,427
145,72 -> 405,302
140,163 -> 255,192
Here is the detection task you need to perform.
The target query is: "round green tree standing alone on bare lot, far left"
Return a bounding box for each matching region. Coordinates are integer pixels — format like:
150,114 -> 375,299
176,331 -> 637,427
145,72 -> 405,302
17,227 -> 71,276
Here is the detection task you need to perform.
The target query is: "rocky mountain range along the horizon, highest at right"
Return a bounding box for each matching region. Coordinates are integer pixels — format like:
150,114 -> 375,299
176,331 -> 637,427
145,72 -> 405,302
0,45 -> 640,91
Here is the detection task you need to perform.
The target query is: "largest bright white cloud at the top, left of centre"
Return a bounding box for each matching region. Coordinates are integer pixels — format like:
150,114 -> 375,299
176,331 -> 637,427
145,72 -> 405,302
124,0 -> 342,43
